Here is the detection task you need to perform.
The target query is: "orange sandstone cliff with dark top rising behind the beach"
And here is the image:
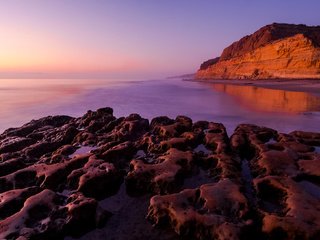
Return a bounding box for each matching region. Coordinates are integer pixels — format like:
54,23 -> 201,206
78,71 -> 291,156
196,23 -> 320,79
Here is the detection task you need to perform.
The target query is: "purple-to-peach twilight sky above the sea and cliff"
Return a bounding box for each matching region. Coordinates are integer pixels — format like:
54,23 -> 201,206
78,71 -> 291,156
0,0 -> 320,78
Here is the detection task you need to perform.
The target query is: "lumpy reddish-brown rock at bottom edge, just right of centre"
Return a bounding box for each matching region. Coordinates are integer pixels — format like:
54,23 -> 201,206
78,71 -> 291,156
148,180 -> 249,239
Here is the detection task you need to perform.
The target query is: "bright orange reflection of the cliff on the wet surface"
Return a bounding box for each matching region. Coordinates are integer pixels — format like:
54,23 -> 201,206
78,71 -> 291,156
212,84 -> 320,113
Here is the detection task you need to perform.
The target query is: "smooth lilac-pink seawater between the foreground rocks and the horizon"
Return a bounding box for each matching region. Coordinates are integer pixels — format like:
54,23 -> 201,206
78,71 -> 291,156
0,79 -> 320,135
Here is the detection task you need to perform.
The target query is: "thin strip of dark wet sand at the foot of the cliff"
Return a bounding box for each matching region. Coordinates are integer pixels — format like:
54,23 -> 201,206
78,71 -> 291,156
183,78 -> 320,96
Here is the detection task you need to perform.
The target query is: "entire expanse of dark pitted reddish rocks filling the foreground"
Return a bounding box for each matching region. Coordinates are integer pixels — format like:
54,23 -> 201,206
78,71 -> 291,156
0,108 -> 320,239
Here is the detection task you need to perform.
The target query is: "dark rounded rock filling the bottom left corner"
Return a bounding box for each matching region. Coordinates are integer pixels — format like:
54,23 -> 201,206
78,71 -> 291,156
0,190 -> 106,239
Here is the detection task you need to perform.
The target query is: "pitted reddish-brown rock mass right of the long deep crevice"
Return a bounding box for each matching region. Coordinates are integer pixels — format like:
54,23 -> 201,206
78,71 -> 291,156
231,125 -> 320,239
